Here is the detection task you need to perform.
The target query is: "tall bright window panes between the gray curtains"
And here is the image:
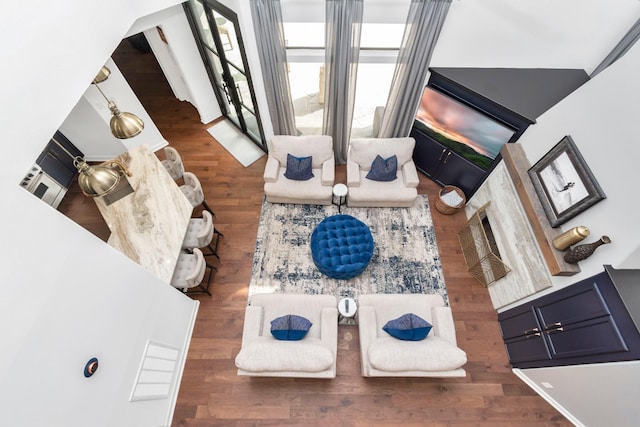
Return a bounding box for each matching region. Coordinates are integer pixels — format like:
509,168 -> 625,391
281,0 -> 409,137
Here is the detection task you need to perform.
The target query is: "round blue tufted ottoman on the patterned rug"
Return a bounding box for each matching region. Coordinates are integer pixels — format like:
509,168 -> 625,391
311,215 -> 373,280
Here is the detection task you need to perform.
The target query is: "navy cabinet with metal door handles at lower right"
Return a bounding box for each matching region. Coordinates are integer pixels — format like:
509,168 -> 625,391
498,267 -> 640,368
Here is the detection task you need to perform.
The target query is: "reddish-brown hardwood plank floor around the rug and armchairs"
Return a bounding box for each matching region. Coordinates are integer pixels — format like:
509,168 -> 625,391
60,37 -> 571,427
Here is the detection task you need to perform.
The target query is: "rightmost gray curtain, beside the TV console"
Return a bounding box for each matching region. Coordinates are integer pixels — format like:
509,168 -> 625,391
377,0 -> 451,138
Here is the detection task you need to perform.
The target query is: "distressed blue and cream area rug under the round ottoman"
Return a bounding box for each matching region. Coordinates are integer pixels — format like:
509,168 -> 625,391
249,195 -> 448,304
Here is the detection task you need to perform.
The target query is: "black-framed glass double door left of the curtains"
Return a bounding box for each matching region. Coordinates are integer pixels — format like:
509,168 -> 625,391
187,0 -> 266,151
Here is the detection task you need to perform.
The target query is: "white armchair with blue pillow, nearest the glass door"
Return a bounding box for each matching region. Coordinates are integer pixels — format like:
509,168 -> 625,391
263,135 -> 335,205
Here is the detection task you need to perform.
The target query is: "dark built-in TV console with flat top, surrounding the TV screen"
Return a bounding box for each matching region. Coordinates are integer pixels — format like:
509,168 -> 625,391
411,67 -> 589,199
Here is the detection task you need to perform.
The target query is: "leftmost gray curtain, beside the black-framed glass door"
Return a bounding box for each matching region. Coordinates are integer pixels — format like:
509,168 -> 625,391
251,0 -> 298,135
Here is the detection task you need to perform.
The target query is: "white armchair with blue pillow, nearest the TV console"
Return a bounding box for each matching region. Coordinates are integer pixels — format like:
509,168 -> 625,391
347,137 -> 419,207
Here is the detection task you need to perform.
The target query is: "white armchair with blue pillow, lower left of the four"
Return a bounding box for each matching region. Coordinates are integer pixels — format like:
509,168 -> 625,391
236,294 -> 338,378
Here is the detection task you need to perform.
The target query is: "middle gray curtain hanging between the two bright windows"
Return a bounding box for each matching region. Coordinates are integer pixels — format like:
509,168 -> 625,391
322,0 -> 363,164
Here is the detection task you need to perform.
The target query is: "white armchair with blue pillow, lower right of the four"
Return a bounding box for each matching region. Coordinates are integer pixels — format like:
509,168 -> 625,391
358,294 -> 467,377
